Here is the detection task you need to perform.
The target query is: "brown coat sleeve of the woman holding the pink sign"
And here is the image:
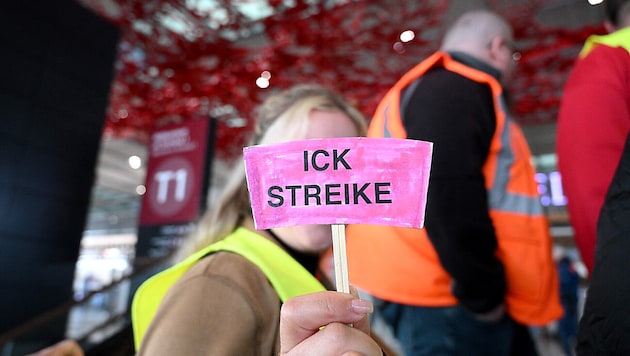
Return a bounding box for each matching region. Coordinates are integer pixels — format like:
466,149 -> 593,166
138,252 -> 281,356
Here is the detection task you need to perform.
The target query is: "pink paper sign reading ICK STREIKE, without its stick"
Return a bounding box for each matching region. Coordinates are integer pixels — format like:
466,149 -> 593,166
243,137 -> 433,230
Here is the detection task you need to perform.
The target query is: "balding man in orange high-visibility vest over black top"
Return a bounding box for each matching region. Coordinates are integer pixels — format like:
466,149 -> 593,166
348,10 -> 562,356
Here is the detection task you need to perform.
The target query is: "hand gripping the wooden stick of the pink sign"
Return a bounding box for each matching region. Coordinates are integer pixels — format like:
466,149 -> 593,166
280,291 -> 382,356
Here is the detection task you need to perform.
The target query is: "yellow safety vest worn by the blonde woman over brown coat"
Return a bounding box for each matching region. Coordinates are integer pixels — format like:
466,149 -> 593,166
131,228 -> 325,350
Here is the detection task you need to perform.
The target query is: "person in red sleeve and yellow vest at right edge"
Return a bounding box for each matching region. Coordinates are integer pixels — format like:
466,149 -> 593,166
556,0 -> 630,272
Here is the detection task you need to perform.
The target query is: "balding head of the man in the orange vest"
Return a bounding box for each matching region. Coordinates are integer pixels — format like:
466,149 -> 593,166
440,10 -> 514,80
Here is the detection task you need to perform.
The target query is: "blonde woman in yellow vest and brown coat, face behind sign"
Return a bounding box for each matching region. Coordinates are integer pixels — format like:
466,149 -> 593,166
132,85 -> 366,356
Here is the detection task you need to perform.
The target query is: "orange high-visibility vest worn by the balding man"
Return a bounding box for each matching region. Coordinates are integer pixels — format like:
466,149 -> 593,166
347,52 -> 562,325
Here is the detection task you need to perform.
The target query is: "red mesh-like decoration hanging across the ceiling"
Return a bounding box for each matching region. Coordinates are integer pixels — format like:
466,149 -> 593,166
81,0 -> 603,158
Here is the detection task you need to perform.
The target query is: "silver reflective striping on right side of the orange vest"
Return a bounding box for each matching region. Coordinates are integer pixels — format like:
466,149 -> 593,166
488,95 -> 543,215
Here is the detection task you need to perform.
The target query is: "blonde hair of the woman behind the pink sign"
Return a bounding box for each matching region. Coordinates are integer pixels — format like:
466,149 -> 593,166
176,84 -> 367,260
